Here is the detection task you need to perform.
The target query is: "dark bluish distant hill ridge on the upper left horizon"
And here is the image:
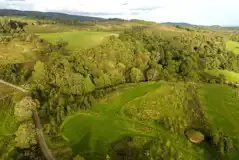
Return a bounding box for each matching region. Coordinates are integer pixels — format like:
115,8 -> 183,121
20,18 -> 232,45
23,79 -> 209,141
0,9 -> 107,22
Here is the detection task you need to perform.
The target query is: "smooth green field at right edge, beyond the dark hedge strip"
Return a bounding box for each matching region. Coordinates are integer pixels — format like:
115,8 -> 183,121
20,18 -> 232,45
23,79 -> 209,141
199,84 -> 239,159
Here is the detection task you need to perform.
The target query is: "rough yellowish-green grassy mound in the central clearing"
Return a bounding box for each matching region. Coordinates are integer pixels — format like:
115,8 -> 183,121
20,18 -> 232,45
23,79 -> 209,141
124,83 -> 189,120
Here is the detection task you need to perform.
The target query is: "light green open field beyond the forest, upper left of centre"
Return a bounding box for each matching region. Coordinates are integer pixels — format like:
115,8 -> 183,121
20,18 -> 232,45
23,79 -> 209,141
40,32 -> 116,50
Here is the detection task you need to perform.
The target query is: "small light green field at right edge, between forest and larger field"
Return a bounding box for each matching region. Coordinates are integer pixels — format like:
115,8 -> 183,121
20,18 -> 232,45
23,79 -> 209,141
205,69 -> 239,83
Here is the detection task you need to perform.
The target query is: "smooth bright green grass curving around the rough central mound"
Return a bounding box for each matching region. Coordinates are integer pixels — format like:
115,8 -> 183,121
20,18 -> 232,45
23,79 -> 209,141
61,83 -> 217,159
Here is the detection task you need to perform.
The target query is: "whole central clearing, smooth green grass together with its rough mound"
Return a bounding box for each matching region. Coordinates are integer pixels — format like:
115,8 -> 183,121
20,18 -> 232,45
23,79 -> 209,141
61,82 -> 217,159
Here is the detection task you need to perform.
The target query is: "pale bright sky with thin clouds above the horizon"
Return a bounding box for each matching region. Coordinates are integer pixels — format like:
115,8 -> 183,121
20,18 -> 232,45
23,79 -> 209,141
0,0 -> 239,26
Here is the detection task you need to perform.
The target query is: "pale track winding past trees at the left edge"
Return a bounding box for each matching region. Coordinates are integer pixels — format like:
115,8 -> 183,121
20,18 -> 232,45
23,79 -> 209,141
0,79 -> 55,160
